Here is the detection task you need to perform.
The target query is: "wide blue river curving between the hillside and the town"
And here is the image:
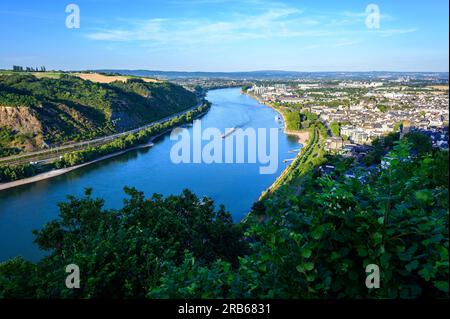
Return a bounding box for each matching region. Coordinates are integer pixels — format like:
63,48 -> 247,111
0,88 -> 299,261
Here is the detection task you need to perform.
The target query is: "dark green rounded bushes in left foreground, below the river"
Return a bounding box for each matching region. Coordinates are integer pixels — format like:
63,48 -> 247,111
0,188 -> 245,298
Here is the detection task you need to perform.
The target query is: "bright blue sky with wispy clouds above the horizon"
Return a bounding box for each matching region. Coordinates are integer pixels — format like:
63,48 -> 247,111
0,0 -> 449,72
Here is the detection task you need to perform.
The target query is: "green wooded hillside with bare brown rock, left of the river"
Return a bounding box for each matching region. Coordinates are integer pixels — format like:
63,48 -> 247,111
0,73 -> 196,156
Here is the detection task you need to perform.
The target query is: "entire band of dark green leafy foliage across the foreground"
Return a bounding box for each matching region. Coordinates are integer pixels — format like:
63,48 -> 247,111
0,140 -> 449,298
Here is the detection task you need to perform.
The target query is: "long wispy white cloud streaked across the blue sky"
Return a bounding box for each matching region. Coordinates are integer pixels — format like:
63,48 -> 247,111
85,4 -> 416,50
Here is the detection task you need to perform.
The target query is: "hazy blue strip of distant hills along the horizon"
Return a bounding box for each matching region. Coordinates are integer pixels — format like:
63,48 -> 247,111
95,69 -> 448,80
